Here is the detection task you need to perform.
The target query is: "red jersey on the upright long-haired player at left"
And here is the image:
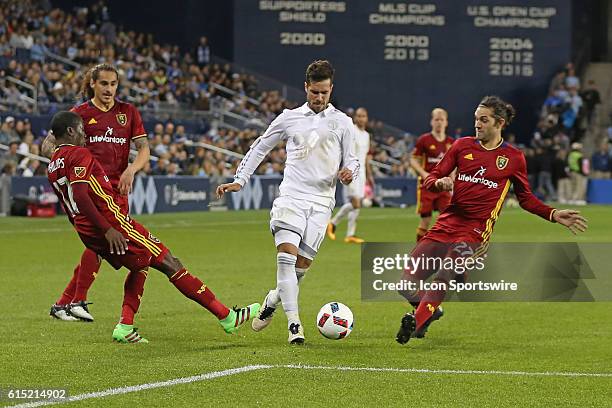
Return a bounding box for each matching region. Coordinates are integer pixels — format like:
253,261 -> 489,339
72,100 -> 147,182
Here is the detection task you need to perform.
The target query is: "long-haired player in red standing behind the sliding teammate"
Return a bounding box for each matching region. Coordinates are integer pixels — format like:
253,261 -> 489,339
43,64 -> 150,322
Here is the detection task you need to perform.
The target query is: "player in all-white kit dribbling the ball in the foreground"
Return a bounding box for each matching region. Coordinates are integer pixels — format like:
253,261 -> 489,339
217,60 -> 359,344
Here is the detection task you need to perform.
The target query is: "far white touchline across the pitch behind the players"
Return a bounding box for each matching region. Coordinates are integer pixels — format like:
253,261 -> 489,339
0,214 -> 397,235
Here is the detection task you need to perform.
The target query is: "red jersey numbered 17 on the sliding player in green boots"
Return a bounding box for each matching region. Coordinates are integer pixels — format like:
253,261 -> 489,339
47,145 -> 129,237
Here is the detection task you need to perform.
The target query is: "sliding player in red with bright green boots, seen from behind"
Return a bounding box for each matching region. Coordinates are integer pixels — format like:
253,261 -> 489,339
48,112 -> 260,343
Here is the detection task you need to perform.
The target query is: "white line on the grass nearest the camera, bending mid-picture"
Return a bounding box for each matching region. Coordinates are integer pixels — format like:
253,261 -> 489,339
4,364 -> 612,408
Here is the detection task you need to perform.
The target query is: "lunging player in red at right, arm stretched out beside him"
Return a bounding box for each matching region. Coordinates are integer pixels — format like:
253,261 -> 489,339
396,96 -> 587,344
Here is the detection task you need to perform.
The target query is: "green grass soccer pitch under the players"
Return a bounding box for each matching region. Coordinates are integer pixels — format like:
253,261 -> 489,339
0,206 -> 612,408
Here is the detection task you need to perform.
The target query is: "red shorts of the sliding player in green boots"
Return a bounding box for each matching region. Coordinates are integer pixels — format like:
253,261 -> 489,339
79,218 -> 169,271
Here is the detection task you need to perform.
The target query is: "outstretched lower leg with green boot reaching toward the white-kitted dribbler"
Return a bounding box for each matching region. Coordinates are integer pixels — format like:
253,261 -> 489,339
154,252 -> 261,333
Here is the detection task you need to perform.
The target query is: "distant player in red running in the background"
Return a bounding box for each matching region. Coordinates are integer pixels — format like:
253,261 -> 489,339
410,108 -> 453,241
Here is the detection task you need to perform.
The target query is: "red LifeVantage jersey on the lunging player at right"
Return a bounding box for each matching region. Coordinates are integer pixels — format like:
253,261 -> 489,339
423,137 -> 554,240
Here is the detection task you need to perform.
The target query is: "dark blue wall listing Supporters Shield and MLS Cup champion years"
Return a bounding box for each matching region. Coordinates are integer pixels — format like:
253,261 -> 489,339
234,0 -> 572,140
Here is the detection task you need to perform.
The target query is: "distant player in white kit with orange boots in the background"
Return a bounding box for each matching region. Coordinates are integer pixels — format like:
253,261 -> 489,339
327,108 -> 374,244
